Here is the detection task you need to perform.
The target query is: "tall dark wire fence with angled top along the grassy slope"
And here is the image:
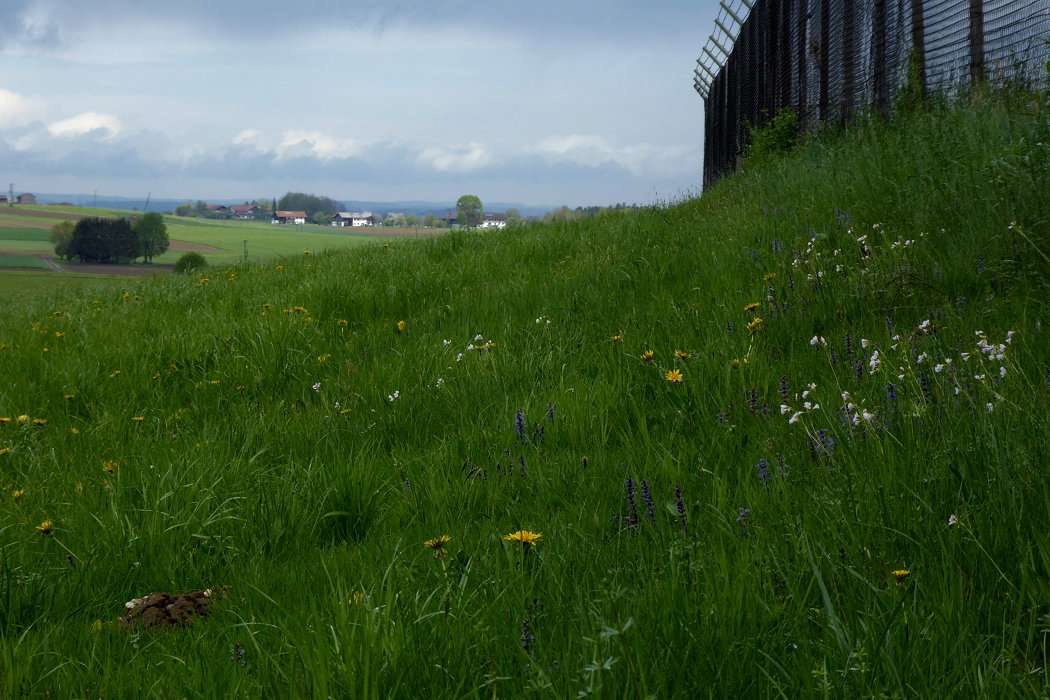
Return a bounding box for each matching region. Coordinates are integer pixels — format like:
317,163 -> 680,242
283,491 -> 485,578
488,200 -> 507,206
694,0 -> 1050,187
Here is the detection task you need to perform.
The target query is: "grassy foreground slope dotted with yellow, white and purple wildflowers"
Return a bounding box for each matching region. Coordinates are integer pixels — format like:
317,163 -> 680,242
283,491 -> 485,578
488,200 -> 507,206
0,91 -> 1050,698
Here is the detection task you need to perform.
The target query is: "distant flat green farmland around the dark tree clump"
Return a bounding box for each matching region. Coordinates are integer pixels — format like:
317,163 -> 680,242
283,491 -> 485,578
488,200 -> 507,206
0,205 -> 441,300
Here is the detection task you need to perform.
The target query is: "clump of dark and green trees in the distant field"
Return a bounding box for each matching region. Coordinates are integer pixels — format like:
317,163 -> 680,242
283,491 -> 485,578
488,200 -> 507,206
51,212 -> 170,262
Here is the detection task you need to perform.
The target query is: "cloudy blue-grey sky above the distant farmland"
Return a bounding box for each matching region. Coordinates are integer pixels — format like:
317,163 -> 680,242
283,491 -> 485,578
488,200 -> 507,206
0,0 -> 718,207
